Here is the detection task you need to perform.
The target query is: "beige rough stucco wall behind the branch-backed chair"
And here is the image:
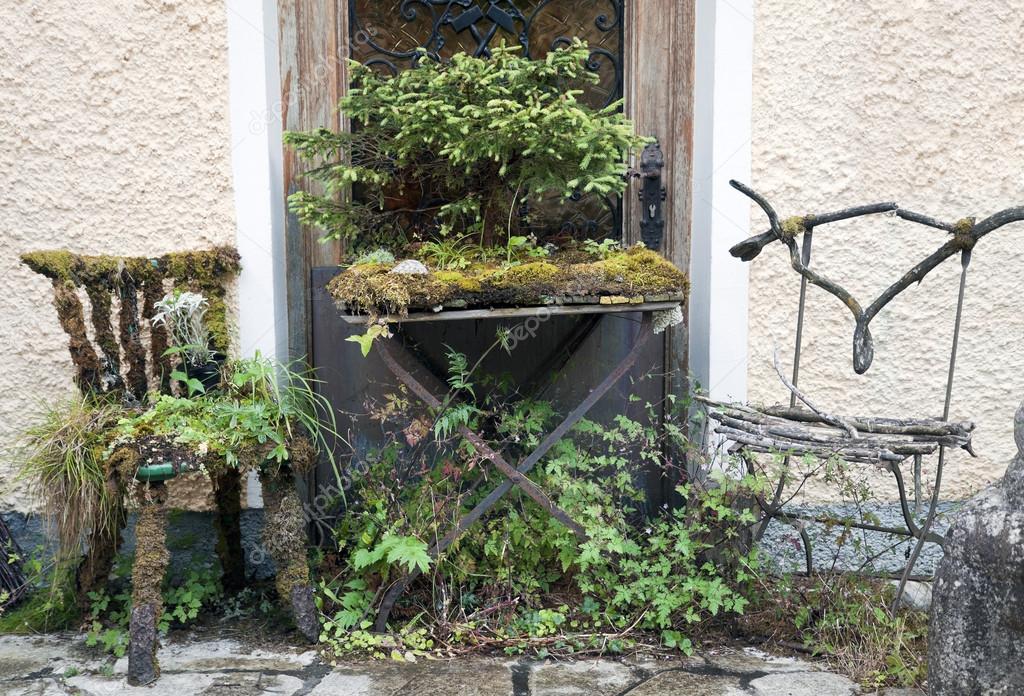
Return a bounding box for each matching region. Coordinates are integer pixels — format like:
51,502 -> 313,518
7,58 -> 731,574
737,0 -> 1024,496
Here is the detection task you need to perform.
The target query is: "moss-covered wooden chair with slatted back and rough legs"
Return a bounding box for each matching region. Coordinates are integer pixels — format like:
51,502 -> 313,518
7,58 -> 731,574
22,248 -> 317,684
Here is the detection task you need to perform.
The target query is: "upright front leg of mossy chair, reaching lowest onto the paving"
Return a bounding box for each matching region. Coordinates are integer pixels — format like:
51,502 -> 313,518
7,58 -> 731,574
128,483 -> 170,686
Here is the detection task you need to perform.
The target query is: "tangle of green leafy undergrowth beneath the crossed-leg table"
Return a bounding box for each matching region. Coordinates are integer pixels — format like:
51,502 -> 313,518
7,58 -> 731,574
318,348 -> 764,657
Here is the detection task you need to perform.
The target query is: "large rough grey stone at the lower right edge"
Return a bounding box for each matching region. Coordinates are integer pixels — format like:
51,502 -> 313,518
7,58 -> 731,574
928,404 -> 1024,696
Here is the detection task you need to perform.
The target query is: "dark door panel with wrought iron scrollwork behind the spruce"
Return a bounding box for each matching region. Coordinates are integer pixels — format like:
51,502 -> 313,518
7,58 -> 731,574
349,0 -> 626,238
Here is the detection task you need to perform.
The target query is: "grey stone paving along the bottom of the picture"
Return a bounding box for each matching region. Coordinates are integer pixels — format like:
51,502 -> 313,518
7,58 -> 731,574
0,635 -> 923,696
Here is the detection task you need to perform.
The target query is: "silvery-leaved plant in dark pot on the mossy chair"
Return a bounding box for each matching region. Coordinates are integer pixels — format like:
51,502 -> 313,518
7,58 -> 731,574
153,290 -> 225,392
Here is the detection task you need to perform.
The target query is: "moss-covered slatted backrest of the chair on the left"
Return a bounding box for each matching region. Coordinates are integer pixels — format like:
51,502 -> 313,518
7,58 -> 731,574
22,247 -> 241,399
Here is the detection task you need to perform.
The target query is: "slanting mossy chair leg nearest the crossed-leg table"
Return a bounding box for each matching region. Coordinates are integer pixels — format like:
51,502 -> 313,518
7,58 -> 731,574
260,467 -> 319,643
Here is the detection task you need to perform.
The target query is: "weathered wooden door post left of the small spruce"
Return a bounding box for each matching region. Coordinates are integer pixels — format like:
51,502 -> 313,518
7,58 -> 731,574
278,0 -> 348,358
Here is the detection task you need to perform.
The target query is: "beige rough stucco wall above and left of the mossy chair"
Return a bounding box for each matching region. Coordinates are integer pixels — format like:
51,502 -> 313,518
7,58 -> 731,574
0,0 -> 234,510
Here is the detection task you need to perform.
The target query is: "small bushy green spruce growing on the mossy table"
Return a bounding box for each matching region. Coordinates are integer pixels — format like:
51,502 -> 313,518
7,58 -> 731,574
285,41 -> 643,247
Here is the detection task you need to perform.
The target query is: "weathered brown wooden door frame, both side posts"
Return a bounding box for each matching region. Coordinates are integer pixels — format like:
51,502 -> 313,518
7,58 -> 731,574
278,0 -> 696,374
